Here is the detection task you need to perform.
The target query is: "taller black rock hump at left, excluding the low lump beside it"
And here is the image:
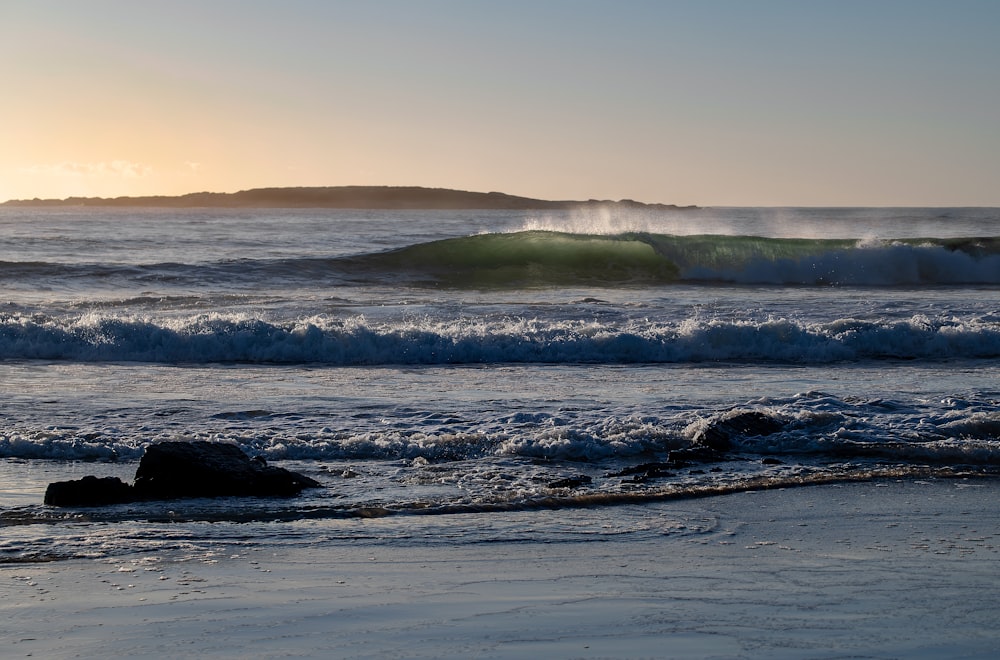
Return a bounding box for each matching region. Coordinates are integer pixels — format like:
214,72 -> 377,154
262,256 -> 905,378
133,442 -> 320,500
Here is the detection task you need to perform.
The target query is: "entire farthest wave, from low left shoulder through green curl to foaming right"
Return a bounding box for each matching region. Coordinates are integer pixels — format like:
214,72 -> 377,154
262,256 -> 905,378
7,230 -> 1000,288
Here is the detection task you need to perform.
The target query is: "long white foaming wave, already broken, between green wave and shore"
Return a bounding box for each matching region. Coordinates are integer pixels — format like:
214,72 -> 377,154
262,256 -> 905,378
0,313 -> 1000,366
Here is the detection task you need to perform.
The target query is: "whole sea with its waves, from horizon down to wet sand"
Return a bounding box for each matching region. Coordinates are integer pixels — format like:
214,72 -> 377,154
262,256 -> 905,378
0,207 -> 1000,562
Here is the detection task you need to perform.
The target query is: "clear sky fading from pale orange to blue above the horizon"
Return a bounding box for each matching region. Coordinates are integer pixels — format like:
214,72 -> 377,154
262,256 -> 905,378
0,0 -> 1000,206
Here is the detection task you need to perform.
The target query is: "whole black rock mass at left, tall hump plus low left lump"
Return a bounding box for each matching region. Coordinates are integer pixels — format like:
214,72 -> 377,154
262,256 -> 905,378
45,441 -> 322,506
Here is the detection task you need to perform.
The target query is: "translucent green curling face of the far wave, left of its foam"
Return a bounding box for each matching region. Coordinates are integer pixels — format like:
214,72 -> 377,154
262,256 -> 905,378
365,231 -> 679,287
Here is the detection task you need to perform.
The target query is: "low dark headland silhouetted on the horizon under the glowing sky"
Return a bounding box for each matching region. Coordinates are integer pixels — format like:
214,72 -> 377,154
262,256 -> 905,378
0,186 -> 696,211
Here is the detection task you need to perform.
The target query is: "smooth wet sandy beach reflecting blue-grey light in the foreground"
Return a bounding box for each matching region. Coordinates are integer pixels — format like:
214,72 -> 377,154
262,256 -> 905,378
0,480 -> 1000,658
